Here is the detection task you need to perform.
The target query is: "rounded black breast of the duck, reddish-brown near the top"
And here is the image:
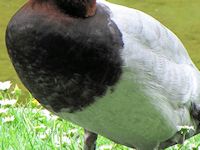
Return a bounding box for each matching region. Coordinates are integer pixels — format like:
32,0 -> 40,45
6,1 -> 123,112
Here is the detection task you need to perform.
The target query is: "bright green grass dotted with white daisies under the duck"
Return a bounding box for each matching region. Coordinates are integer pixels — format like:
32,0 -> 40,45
0,82 -> 200,150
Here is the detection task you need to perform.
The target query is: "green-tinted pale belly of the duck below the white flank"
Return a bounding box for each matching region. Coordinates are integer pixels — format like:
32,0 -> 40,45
47,73 -> 177,149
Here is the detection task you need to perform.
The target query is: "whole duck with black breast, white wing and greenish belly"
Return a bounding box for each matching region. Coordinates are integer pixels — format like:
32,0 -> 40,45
6,0 -> 200,150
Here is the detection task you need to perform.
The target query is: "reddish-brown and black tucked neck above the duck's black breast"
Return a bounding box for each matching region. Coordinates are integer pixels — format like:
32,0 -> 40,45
53,0 -> 96,17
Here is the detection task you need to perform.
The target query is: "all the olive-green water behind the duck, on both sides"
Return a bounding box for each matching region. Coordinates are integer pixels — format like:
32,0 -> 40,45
0,0 -> 200,90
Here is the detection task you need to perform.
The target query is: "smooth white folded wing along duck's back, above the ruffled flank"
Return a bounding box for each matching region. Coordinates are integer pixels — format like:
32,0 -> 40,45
99,0 -> 195,67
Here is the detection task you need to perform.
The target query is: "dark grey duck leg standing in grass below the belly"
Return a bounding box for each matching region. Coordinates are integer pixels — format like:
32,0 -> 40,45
84,129 -> 98,150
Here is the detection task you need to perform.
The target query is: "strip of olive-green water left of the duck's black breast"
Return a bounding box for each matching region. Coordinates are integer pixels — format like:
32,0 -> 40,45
0,0 -> 25,87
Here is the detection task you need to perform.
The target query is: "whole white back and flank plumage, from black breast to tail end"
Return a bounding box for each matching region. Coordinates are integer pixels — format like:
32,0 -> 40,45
100,0 -> 200,103
